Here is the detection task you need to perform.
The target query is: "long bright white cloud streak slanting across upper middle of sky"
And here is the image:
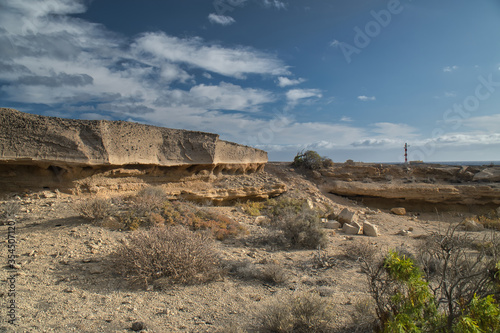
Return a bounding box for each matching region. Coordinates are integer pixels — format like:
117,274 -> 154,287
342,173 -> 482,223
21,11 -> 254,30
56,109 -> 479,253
132,32 -> 289,78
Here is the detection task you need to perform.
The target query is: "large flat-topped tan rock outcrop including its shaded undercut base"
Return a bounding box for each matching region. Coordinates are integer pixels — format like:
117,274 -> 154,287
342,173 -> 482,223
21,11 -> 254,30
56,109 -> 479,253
0,108 -> 285,201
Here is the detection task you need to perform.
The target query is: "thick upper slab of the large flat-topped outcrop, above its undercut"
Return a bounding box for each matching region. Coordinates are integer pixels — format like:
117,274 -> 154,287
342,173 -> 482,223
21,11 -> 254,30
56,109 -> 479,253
0,108 -> 267,166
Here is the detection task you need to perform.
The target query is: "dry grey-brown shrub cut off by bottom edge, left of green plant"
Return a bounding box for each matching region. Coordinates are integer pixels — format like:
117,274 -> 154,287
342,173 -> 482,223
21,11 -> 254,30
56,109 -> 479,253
260,292 -> 333,333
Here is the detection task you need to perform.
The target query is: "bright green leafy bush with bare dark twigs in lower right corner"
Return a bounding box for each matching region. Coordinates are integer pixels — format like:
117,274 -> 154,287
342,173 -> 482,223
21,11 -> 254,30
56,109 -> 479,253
353,227 -> 500,332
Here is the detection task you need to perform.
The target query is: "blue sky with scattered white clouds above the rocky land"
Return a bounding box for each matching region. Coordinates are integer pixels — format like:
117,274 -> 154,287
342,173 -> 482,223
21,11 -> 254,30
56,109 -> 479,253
0,0 -> 500,162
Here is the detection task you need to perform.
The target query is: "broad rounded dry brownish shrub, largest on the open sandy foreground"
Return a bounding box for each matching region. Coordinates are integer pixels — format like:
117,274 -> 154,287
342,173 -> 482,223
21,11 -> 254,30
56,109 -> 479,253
116,226 -> 221,285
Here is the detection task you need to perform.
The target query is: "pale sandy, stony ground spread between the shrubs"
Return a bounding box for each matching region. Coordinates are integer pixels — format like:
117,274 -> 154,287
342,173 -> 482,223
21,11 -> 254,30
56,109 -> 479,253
0,164 -> 488,333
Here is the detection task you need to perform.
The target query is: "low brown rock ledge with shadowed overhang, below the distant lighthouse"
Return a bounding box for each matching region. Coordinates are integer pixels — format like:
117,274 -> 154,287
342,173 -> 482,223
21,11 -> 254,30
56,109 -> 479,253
318,163 -> 500,211
